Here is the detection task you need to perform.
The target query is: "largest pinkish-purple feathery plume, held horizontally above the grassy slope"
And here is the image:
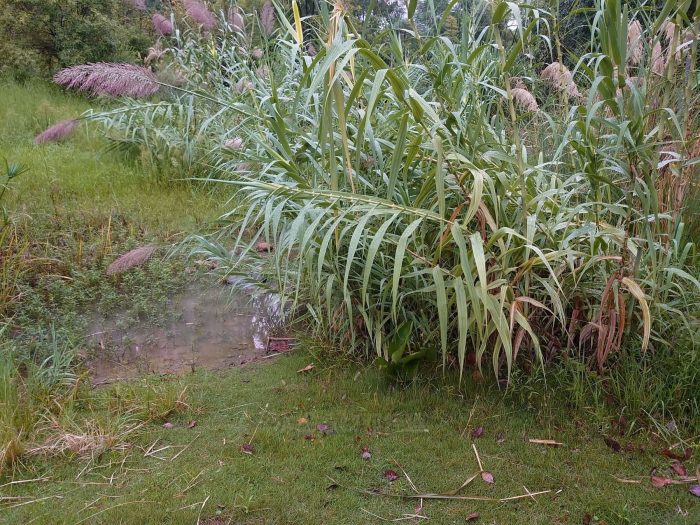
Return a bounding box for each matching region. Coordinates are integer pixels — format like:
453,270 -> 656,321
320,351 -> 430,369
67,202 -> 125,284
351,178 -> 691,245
53,62 -> 160,97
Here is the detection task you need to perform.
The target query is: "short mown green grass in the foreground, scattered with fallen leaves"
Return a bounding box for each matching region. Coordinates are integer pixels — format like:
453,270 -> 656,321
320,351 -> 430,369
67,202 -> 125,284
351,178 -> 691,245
2,352 -> 700,525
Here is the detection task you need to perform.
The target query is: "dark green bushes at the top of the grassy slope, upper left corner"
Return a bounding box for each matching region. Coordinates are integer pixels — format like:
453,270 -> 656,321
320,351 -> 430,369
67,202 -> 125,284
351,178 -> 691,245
0,0 -> 152,79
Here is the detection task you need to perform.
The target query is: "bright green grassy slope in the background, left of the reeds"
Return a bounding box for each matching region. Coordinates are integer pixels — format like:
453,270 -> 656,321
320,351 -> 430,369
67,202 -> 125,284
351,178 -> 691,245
0,80 -> 216,234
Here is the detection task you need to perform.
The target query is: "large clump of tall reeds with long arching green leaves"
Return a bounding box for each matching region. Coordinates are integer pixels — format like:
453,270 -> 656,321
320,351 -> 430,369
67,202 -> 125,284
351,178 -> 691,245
69,0 -> 700,404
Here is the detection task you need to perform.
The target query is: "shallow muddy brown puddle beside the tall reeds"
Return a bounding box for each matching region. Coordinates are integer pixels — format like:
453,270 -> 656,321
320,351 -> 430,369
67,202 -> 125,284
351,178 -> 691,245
85,286 -> 288,386
